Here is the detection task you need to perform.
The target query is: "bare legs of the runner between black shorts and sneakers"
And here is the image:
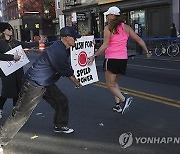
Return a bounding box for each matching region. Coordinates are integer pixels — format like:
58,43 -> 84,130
105,70 -> 125,103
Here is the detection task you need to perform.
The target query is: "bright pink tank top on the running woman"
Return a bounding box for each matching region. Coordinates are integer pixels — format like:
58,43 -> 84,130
105,23 -> 129,59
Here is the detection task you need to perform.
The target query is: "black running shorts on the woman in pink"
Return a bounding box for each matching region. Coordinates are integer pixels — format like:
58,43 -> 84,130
103,59 -> 127,75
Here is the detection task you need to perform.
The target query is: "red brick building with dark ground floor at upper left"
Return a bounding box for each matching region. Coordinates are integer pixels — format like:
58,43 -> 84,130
1,0 -> 55,41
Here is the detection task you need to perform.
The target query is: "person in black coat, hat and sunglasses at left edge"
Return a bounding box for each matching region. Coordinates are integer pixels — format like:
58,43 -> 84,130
0,22 -> 39,119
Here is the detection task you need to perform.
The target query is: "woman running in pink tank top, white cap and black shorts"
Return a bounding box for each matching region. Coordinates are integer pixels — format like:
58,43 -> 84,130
89,6 -> 151,114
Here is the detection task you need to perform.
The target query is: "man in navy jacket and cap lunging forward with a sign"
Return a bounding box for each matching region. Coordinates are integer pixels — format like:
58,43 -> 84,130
0,26 -> 81,152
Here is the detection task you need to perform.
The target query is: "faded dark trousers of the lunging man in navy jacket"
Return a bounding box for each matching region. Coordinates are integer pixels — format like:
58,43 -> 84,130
0,81 -> 69,145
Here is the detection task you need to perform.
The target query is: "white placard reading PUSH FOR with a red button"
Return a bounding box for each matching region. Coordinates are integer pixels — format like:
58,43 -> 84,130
71,36 -> 99,86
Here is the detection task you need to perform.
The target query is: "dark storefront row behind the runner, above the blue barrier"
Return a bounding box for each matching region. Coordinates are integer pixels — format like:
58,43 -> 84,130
63,0 -> 180,37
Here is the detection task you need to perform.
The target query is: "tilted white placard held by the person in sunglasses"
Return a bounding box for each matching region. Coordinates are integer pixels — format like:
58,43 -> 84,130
0,45 -> 29,76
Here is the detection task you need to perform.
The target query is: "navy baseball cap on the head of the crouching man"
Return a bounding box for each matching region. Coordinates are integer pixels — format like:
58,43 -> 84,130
60,26 -> 81,38
